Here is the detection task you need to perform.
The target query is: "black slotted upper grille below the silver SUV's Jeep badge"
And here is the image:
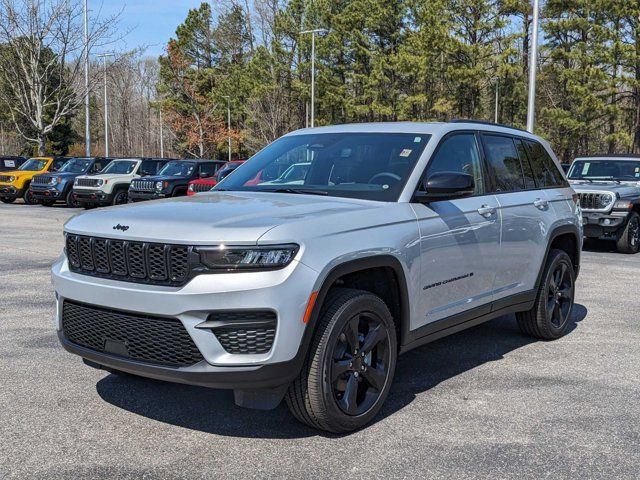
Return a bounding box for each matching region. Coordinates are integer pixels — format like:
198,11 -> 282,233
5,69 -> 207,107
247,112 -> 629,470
66,234 -> 192,286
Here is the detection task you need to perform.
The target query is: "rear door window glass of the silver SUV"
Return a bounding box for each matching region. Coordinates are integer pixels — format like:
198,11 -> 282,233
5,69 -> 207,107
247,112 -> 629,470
482,134 -> 524,192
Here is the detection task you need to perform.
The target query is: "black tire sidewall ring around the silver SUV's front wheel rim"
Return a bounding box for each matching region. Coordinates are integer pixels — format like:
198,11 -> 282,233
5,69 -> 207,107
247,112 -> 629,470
318,294 -> 397,431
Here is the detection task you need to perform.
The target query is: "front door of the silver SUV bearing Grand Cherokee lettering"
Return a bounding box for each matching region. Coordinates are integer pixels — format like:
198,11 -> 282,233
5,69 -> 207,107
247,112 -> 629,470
412,132 -> 500,328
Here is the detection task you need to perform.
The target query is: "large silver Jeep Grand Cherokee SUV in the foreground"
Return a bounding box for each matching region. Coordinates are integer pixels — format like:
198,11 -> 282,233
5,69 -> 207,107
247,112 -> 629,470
53,122 -> 582,432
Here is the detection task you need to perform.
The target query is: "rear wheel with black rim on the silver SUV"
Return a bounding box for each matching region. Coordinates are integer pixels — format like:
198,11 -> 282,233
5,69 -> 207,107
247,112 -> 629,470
516,249 -> 576,340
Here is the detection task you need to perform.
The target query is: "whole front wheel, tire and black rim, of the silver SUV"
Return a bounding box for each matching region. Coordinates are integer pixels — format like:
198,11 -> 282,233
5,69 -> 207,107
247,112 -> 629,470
285,288 -> 398,433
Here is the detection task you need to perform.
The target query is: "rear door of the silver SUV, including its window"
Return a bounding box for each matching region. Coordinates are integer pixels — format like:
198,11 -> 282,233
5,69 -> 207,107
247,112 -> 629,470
482,133 -> 555,300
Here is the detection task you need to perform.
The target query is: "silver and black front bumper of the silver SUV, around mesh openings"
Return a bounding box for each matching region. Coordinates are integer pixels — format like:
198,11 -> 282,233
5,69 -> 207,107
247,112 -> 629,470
52,257 -> 317,389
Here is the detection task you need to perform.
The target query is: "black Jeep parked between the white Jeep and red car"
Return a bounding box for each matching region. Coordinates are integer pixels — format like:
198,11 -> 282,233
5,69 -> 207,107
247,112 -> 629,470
129,159 -> 226,202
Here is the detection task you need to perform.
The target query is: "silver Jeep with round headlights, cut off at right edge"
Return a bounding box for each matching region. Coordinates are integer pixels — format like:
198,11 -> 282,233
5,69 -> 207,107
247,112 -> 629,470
568,155 -> 640,253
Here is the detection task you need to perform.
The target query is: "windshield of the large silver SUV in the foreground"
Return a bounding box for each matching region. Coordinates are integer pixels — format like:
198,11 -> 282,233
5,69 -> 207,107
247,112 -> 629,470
214,133 -> 429,201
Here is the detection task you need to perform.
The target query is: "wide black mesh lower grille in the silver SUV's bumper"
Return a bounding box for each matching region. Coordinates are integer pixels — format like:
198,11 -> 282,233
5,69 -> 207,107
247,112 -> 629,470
62,300 -> 203,367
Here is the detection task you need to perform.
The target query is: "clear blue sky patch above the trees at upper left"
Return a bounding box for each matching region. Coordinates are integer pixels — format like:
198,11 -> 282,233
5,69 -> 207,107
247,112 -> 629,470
97,0 -> 203,56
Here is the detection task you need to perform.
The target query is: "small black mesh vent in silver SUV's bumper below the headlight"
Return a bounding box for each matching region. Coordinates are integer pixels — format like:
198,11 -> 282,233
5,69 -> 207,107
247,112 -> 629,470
207,310 -> 276,355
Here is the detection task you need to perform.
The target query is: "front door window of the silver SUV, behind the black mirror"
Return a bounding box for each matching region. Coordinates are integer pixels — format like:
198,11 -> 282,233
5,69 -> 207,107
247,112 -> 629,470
425,133 -> 485,195
